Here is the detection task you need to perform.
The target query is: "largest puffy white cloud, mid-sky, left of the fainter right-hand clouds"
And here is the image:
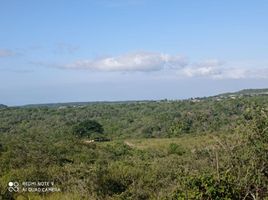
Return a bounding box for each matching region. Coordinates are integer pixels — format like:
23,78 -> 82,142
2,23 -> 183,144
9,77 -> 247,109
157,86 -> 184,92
64,52 -> 187,72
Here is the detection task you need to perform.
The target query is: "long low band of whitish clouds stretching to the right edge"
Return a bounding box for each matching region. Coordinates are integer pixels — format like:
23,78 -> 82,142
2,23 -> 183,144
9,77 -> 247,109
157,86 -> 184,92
25,52 -> 268,79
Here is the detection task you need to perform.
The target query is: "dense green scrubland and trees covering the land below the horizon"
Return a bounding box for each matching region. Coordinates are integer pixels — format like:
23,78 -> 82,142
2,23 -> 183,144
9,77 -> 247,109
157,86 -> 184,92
0,90 -> 268,200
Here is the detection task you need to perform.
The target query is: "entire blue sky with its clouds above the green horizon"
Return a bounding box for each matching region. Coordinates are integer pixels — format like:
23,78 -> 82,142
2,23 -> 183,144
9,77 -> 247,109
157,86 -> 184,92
0,0 -> 268,106
